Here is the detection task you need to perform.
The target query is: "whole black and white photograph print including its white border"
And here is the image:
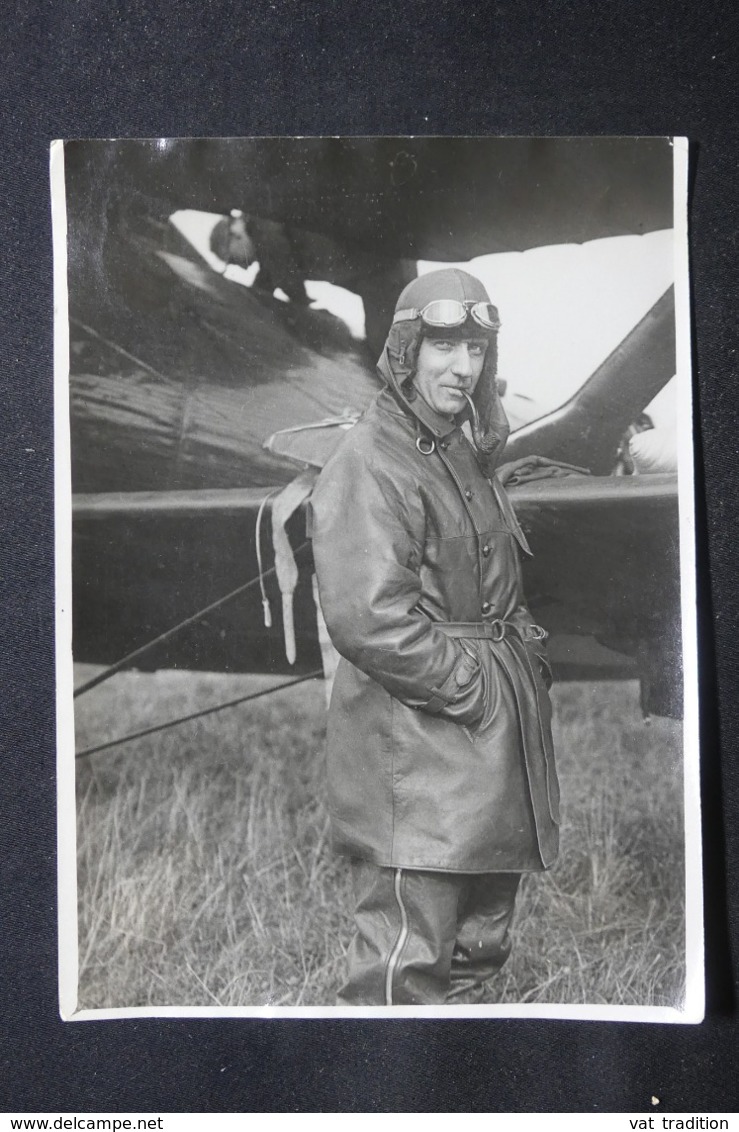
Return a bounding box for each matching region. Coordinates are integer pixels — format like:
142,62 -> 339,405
51,136 -> 704,1022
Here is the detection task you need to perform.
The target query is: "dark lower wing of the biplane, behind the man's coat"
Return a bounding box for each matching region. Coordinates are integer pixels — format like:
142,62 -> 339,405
72,475 -> 680,713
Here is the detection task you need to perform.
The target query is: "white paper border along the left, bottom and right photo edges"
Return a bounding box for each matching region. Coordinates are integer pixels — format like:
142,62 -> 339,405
50,137 -> 705,1023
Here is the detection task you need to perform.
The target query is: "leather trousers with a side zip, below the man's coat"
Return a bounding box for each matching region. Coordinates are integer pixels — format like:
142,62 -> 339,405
337,860 -> 521,1006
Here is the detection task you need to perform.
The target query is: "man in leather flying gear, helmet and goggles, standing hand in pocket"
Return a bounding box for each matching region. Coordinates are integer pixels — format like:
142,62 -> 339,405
312,268 -> 559,1005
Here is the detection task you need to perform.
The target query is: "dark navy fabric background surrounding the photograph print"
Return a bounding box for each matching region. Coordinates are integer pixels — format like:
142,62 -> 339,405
0,0 -> 739,1113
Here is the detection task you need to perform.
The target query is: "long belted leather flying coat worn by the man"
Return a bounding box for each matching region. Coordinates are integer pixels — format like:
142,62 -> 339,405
312,269 -> 559,873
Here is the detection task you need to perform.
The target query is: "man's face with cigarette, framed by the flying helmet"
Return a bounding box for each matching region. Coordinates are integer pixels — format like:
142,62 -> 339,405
413,335 -> 488,417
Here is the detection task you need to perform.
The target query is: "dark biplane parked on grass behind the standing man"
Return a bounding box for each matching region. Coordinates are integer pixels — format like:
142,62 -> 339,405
65,137 -> 681,715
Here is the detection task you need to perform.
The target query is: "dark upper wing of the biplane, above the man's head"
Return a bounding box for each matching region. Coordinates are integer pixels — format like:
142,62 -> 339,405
65,137 -> 672,260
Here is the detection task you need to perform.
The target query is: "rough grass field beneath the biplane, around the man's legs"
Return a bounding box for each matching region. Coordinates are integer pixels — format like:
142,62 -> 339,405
76,668 -> 685,1009
